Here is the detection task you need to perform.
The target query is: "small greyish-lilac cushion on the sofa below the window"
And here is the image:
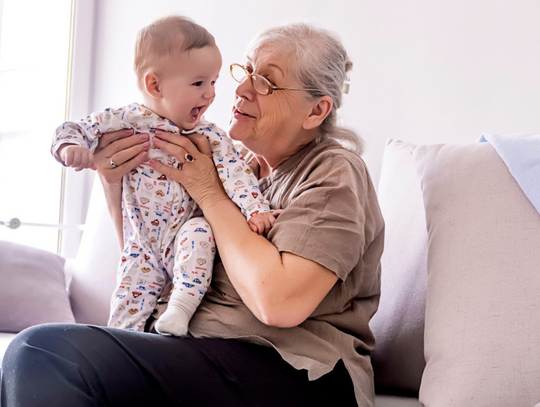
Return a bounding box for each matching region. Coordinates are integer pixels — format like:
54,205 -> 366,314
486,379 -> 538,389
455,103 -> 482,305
0,240 -> 75,332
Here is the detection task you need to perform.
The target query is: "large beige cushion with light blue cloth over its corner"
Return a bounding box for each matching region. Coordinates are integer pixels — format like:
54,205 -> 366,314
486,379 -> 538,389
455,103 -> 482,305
413,143 -> 540,407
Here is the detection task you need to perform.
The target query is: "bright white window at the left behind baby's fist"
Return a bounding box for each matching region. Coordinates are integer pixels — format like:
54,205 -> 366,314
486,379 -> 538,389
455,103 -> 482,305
0,0 -> 74,252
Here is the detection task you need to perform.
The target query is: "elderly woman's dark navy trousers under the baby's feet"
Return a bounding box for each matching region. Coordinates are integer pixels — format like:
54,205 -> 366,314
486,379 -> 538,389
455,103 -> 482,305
0,324 -> 356,407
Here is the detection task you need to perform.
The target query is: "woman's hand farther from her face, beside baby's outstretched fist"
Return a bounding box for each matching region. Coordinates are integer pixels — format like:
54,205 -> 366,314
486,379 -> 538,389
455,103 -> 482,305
94,129 -> 150,185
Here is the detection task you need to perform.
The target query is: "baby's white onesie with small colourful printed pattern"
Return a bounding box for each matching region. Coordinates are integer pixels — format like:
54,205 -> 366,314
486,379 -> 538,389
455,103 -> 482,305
51,103 -> 270,331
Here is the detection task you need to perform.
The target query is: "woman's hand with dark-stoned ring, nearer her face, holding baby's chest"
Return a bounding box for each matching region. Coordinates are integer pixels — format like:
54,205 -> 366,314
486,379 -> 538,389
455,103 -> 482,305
150,130 -> 229,211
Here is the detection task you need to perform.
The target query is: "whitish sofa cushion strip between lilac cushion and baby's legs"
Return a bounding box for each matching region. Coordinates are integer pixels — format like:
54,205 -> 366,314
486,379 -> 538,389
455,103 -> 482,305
69,177 -> 121,326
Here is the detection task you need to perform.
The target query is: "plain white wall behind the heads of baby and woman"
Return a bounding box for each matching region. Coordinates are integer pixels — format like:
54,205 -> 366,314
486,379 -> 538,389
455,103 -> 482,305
86,0 -> 540,185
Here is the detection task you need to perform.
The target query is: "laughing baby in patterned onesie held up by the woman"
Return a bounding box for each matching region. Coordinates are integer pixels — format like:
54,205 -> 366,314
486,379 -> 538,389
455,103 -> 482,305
51,16 -> 273,336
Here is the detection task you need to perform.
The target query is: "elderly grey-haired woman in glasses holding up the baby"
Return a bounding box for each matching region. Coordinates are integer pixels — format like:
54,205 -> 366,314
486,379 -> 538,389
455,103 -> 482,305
1,24 -> 384,407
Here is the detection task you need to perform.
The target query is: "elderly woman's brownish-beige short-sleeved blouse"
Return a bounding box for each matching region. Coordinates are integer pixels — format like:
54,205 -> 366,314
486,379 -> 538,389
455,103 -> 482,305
189,141 -> 384,406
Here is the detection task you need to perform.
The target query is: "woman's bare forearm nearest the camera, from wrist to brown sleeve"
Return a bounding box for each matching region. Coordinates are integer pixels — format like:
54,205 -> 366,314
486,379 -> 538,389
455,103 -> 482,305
203,197 -> 337,327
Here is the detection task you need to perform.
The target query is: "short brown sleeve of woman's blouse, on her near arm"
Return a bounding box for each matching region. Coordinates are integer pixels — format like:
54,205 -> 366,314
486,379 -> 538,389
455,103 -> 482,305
268,152 -> 369,280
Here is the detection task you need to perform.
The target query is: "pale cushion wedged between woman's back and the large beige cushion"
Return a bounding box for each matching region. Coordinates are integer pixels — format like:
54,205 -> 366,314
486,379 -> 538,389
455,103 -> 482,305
370,140 -> 427,395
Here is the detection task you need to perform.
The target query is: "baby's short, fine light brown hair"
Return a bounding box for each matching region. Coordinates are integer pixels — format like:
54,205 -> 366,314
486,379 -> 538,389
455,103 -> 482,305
134,15 -> 216,90
